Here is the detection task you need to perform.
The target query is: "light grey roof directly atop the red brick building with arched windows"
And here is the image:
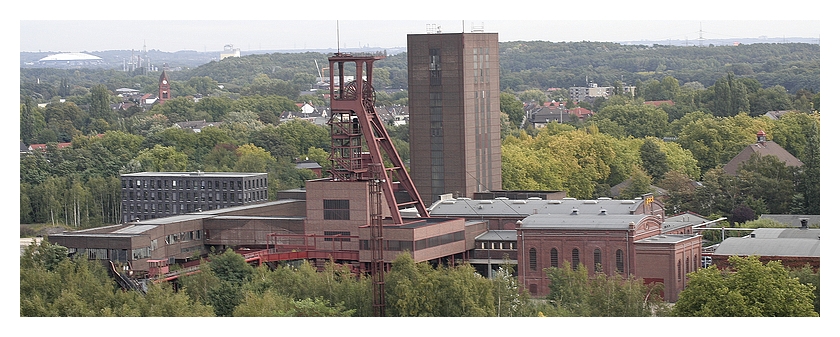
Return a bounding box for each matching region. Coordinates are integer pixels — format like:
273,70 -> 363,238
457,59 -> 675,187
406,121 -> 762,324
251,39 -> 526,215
520,214 -> 650,230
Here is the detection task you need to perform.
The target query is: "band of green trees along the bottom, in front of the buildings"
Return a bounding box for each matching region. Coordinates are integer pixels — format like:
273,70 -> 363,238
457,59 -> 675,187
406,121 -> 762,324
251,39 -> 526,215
20,241 -> 820,316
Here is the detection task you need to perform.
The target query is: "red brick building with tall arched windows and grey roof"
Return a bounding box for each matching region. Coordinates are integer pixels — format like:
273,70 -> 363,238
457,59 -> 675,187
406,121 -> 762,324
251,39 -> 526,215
517,210 -> 702,302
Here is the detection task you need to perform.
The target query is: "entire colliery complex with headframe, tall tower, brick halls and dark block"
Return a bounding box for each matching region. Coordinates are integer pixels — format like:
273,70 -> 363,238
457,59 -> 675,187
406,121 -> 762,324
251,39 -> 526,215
49,33 -> 808,308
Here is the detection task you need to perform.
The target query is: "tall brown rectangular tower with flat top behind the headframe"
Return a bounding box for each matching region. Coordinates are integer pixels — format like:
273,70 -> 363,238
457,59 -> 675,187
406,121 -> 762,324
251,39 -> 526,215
408,33 -> 502,206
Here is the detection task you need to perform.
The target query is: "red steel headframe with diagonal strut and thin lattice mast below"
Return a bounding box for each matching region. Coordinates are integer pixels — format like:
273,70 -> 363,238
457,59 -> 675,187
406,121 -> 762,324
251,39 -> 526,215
329,53 -> 429,316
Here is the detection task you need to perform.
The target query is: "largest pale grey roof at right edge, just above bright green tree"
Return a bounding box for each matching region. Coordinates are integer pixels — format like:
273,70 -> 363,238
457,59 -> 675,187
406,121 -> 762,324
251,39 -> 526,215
713,237 -> 820,257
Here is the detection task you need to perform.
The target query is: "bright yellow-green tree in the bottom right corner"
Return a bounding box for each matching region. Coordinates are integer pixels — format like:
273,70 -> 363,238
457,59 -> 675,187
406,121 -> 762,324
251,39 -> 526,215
673,256 -> 817,317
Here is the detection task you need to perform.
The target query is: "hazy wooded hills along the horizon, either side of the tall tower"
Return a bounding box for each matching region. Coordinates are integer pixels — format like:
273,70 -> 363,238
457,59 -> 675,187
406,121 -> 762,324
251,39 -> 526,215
21,41 -> 820,93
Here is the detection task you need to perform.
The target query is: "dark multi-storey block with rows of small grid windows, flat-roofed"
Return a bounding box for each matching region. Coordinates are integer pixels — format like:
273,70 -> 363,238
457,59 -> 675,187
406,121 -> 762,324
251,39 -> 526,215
121,171 -> 268,222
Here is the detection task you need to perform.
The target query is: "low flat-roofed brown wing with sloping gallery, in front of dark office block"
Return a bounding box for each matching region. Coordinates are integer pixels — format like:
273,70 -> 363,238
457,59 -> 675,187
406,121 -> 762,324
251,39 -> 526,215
49,200 -> 305,274
